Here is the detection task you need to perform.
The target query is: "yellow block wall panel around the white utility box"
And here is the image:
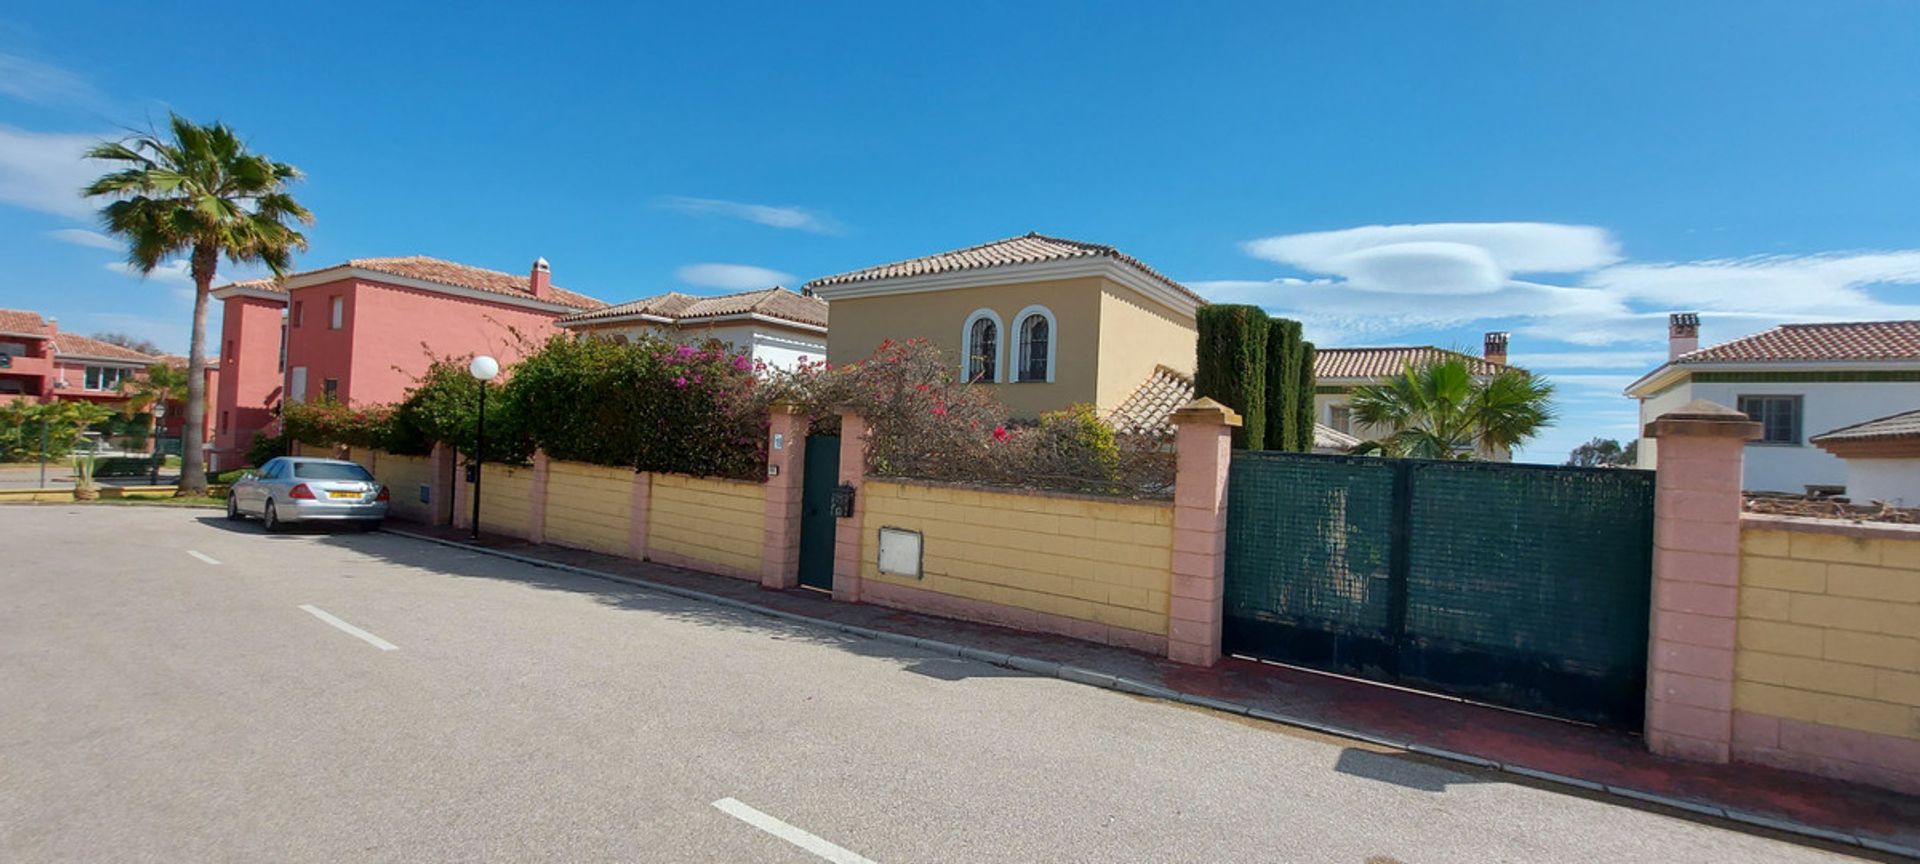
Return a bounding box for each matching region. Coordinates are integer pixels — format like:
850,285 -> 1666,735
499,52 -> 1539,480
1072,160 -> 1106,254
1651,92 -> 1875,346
860,480 -> 1173,636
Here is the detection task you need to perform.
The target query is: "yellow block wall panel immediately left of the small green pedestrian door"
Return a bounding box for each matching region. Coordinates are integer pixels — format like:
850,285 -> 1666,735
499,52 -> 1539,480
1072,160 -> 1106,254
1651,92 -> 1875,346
647,474 -> 766,576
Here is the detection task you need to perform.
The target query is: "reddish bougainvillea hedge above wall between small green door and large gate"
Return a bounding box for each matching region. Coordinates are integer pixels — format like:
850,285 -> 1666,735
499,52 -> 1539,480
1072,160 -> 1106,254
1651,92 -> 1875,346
758,340 -> 1173,497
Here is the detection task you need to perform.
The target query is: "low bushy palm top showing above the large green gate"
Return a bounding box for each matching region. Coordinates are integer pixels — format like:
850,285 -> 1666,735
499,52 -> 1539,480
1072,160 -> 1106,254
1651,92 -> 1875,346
1350,357 -> 1553,459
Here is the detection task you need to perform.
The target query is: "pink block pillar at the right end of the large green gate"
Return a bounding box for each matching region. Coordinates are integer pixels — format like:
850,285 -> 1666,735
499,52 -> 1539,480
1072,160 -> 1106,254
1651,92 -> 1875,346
1645,399 -> 1761,762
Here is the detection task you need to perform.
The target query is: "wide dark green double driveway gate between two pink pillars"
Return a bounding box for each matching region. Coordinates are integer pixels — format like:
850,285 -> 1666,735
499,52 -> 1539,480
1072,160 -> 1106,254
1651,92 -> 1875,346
1223,453 -> 1653,730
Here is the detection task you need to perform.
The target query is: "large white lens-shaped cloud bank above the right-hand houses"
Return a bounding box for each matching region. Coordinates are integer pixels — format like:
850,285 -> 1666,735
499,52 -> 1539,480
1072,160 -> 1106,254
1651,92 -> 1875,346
1192,223 -> 1920,355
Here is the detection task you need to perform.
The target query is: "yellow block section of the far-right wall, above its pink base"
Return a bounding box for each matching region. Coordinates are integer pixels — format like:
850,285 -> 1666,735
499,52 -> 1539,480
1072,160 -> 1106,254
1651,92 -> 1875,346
1734,520 -> 1920,739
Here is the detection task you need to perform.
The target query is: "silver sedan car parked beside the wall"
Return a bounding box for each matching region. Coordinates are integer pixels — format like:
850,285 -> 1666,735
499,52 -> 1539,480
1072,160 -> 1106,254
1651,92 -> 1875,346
227,457 -> 388,532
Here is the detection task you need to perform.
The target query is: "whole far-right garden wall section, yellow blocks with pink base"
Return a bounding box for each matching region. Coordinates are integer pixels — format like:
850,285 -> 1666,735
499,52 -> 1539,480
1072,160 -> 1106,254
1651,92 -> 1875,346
1732,515 -> 1920,793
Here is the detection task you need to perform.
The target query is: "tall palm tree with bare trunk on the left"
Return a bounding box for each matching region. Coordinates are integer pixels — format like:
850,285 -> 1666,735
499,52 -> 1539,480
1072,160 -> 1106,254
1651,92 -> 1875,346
84,113 -> 313,495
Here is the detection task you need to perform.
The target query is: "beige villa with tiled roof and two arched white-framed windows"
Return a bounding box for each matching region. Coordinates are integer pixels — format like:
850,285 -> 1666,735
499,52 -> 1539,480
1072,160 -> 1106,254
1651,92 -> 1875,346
806,234 -> 1206,417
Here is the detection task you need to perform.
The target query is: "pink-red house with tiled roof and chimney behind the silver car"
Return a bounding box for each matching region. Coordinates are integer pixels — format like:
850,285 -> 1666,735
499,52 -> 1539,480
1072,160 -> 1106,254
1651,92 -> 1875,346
213,255 -> 607,468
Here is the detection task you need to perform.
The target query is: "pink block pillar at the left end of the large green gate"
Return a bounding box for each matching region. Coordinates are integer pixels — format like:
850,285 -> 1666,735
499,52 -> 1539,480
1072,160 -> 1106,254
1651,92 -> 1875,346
1167,399 -> 1240,666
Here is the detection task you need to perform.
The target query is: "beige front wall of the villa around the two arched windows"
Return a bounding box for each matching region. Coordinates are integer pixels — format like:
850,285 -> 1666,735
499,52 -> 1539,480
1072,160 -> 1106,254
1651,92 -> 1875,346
828,276 -> 1113,417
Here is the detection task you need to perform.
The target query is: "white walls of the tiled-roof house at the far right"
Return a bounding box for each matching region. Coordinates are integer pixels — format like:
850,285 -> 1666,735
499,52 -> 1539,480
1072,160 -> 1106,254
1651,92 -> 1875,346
1640,382 -> 1920,493
